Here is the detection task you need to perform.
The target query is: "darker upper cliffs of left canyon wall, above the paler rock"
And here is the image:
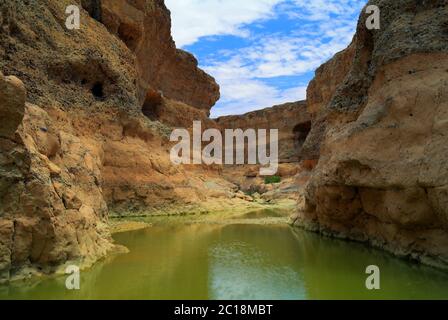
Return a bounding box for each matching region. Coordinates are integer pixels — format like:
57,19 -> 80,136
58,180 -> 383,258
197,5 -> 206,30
0,0 -> 219,114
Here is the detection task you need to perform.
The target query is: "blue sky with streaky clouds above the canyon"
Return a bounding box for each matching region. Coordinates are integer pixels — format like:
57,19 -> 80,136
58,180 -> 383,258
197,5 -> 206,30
165,0 -> 367,117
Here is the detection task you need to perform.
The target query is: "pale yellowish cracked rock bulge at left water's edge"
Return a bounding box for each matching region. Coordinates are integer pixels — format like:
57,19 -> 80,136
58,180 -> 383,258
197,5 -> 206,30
0,77 -> 115,282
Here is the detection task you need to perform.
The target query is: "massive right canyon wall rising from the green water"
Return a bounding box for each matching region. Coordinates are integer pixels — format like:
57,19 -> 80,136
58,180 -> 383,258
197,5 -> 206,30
294,0 -> 448,268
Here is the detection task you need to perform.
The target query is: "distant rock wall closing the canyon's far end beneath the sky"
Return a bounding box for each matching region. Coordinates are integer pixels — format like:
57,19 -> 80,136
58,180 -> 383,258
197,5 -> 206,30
216,101 -> 311,163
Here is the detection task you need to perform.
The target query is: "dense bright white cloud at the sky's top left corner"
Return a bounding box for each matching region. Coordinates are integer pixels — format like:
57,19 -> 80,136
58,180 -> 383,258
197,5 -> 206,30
165,0 -> 284,47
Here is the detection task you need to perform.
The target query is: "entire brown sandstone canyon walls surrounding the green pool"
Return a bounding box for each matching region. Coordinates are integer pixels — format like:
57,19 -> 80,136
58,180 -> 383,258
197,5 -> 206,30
0,0 -> 448,283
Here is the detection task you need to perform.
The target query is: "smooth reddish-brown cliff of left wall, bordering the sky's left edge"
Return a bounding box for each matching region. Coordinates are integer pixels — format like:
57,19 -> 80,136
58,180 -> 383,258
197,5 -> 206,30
99,0 -> 219,114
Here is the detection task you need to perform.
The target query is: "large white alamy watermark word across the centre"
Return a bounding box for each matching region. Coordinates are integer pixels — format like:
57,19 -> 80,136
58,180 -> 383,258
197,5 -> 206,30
170,121 -> 279,176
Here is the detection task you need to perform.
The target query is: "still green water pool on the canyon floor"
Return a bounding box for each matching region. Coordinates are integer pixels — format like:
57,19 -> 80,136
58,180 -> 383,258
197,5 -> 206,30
0,218 -> 448,299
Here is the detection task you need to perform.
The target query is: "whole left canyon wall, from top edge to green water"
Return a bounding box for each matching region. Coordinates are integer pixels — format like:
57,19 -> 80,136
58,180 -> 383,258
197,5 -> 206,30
0,0 -> 228,282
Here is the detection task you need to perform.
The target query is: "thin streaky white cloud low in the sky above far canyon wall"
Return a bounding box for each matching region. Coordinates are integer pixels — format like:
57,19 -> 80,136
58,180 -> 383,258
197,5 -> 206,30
204,26 -> 352,116
